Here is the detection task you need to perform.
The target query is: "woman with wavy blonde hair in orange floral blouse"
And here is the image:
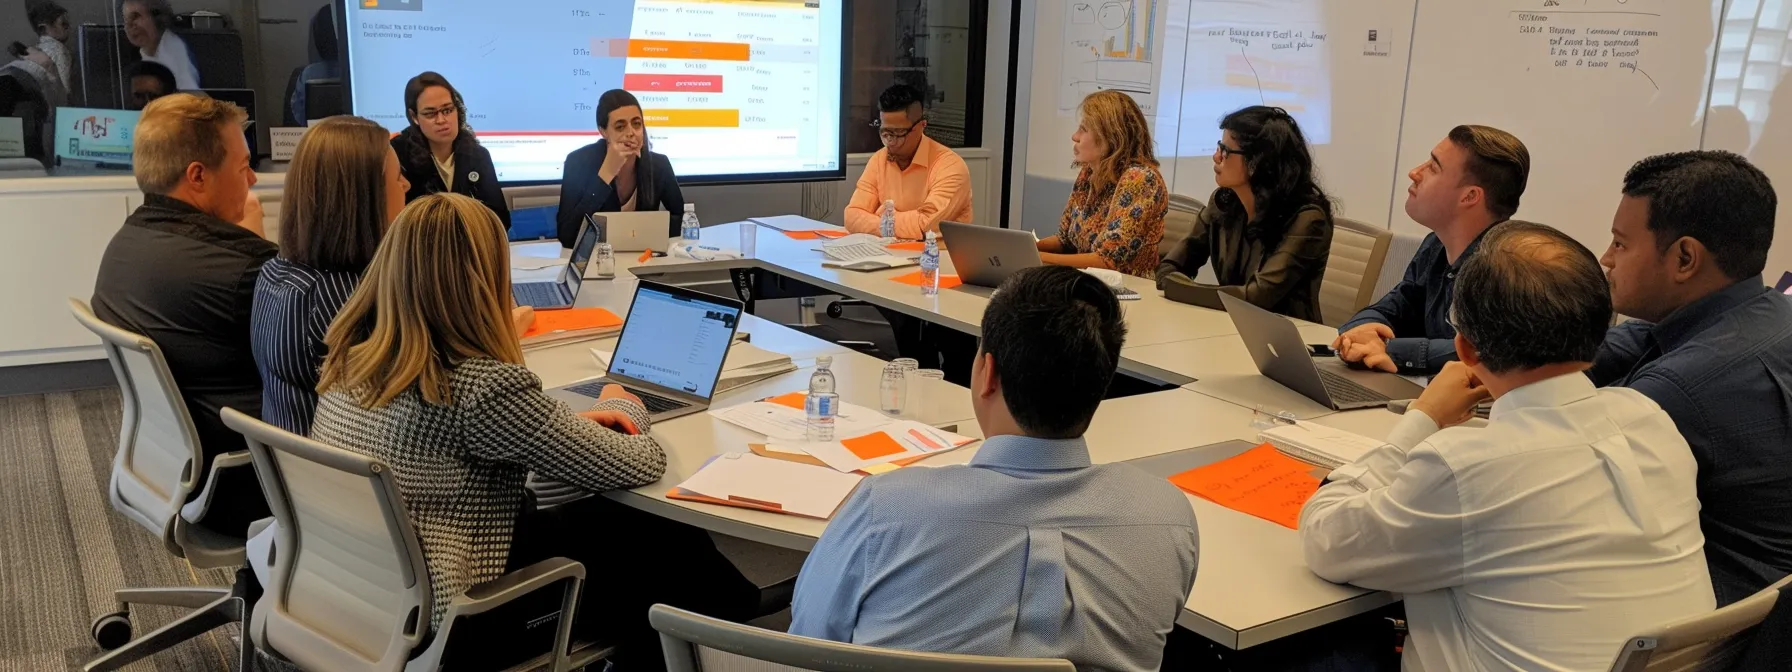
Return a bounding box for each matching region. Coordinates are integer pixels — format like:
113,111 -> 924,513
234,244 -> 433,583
1039,90 -> 1170,278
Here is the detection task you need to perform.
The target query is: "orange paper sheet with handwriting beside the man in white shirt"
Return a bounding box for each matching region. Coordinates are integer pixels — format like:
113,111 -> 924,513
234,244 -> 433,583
1170,443 -> 1319,530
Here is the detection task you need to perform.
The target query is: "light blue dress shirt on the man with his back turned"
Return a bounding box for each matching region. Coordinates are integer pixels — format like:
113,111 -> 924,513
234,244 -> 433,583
790,435 -> 1199,670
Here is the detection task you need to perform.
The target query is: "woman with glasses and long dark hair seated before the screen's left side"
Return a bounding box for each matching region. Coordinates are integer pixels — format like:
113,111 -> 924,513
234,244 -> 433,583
392,72 -> 511,231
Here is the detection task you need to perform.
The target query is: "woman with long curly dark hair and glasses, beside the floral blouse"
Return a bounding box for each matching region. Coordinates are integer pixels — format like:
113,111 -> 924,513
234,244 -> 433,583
1158,106 -> 1331,323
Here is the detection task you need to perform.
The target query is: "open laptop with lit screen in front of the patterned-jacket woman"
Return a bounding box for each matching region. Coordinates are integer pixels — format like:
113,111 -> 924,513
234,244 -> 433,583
548,280 -> 744,423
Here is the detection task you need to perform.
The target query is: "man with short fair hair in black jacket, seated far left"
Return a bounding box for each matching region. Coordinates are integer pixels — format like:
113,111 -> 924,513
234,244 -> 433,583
93,93 -> 276,462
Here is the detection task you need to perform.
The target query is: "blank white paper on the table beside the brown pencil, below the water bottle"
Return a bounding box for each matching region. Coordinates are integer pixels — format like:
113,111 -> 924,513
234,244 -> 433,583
677,453 -> 864,520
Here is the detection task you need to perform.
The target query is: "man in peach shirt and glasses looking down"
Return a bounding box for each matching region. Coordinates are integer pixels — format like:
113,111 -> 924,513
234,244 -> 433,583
846,84 -> 971,240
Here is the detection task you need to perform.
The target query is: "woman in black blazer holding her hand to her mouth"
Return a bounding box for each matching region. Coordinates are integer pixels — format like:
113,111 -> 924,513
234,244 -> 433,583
556,88 -> 685,247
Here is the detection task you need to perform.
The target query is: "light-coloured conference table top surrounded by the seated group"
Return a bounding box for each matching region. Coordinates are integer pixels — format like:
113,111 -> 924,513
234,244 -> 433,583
514,222 -> 1398,649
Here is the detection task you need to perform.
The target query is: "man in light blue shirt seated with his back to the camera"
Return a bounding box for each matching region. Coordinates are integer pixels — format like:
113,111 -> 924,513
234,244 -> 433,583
790,267 -> 1199,670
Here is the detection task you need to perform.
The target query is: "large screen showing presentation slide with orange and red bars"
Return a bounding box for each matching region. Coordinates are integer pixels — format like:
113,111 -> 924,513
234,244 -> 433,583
344,0 -> 846,183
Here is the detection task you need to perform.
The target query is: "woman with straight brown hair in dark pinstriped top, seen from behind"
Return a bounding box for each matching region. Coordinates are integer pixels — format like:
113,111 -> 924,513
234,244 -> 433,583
249,116 -> 410,435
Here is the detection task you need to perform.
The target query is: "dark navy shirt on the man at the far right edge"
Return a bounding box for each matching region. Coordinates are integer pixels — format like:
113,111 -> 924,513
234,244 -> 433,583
1588,278 -> 1792,606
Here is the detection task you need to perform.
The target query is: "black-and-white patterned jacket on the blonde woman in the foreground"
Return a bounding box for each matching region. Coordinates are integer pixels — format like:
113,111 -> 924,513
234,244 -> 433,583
312,358 -> 667,629
